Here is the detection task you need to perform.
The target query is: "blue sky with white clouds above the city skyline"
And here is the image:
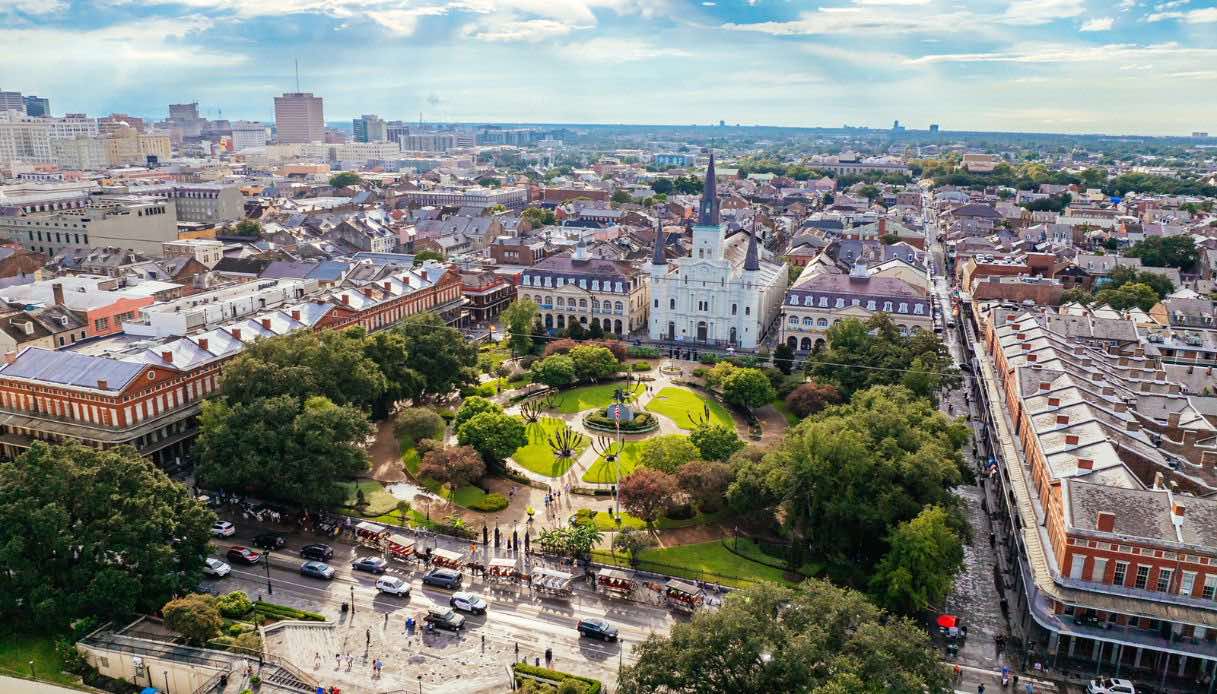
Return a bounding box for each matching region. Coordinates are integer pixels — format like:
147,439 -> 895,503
0,0 -> 1217,134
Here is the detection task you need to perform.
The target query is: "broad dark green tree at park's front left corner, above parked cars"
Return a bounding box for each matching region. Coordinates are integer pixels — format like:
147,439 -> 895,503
195,396 -> 372,505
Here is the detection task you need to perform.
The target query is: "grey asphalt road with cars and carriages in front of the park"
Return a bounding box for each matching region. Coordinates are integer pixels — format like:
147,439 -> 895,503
204,525 -> 673,679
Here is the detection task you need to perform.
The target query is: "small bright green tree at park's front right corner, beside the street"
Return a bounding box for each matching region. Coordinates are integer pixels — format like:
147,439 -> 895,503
870,506 -> 964,617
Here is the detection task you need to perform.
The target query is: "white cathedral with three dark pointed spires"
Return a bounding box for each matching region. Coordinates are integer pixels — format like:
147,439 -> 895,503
646,153 -> 786,349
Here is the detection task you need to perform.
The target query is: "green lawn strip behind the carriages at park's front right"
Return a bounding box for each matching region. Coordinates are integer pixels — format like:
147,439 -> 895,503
593,538 -> 808,587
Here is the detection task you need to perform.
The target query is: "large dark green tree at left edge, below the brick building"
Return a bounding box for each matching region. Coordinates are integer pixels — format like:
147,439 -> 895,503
0,442 -> 215,631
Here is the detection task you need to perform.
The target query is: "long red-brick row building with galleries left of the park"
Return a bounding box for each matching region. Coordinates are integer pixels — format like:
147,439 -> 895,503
0,259 -> 464,466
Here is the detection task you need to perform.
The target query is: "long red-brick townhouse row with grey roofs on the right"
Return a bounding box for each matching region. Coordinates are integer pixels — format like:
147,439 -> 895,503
977,304 -> 1217,681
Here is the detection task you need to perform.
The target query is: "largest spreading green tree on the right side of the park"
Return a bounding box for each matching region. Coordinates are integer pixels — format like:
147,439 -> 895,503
728,386 -> 969,581
